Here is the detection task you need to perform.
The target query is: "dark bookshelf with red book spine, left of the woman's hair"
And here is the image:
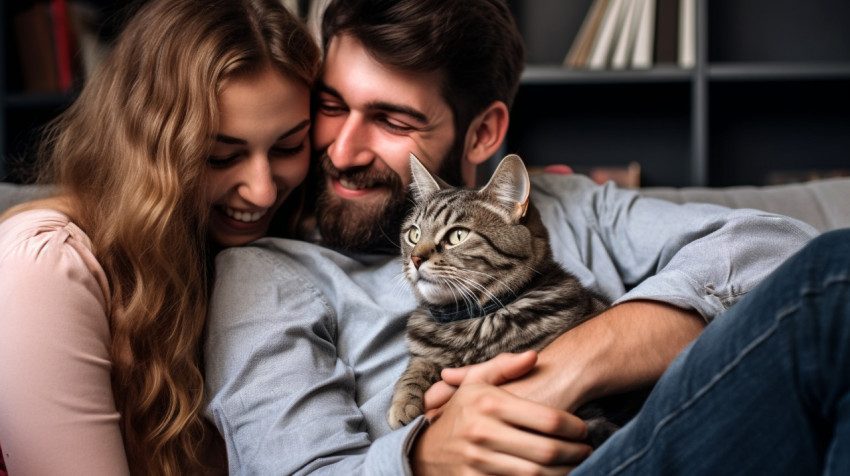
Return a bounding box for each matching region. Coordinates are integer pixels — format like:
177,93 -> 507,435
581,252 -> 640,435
0,0 -> 112,182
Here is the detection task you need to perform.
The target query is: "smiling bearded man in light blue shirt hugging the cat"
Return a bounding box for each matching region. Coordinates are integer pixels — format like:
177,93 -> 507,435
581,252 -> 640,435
200,0 -> 828,474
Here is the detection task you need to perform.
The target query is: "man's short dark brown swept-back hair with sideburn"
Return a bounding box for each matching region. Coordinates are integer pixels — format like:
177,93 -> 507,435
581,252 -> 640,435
322,0 -> 525,185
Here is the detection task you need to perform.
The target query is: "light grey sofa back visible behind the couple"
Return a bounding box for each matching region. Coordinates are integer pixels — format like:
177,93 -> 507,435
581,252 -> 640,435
0,178 -> 850,231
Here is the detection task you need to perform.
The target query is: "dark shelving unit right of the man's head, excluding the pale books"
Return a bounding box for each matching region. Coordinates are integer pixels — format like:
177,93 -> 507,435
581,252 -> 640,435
506,0 -> 850,186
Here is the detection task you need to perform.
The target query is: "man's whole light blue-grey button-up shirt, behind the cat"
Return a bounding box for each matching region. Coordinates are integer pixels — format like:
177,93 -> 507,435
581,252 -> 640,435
205,175 -> 817,476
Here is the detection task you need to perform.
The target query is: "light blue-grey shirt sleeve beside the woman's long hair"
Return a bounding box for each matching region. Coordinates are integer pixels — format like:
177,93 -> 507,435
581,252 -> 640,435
205,247 -> 425,475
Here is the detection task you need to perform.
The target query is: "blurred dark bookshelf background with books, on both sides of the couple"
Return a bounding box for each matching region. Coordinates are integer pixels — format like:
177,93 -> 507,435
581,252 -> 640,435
0,0 -> 850,187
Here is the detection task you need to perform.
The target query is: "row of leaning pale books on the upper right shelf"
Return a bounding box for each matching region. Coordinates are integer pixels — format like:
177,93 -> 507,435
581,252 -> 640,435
564,0 -> 696,70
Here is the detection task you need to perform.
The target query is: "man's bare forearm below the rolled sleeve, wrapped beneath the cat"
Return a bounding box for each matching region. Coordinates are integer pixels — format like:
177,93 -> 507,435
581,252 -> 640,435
505,301 -> 705,411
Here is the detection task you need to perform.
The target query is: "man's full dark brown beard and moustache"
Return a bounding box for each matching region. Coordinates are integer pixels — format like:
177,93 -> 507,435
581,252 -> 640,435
316,153 -> 411,252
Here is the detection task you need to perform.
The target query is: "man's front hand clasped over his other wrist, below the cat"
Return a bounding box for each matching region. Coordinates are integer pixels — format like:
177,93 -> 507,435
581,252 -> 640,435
413,352 -> 591,475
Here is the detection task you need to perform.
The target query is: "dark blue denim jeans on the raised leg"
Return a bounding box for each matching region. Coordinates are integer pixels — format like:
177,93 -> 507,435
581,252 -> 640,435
572,229 -> 850,476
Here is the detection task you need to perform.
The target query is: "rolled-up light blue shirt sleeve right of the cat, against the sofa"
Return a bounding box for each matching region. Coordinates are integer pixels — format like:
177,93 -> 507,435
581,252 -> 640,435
564,176 -> 817,320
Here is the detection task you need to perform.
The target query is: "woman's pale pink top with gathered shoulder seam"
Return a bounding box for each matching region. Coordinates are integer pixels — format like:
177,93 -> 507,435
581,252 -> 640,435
0,210 -> 129,476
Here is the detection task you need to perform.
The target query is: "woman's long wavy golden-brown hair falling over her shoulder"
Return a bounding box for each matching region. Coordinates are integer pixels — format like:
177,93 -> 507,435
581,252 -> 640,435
33,0 -> 319,475
